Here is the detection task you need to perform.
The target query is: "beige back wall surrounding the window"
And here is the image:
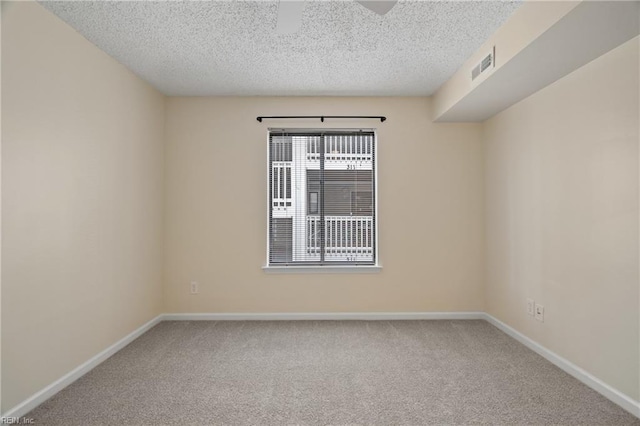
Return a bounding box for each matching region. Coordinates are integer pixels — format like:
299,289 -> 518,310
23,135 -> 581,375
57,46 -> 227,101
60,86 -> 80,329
164,98 -> 484,312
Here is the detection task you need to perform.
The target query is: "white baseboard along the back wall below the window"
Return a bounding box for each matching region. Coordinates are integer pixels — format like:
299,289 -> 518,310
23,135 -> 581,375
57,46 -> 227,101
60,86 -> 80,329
162,312 -> 485,321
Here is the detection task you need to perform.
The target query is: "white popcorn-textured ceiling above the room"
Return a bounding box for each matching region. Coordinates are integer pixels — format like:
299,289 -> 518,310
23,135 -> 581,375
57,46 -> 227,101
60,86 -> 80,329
41,1 -> 521,96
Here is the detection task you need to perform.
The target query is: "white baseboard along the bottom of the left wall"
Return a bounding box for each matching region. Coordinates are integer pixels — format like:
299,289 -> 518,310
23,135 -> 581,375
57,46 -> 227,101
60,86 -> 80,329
2,314 -> 163,418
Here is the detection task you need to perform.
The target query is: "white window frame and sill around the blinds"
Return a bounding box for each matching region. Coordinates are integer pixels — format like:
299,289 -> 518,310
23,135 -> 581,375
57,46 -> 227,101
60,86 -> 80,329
262,127 -> 382,274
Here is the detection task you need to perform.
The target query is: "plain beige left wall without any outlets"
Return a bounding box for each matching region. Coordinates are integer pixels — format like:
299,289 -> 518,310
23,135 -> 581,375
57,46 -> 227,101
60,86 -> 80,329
2,2 -> 164,412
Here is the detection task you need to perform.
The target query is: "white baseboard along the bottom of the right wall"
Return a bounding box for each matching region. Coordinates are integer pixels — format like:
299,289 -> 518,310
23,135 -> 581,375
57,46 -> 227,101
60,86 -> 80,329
484,313 -> 640,418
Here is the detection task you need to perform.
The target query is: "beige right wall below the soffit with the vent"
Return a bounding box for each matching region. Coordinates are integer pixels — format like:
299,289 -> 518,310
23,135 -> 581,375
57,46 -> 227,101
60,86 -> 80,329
483,38 -> 640,400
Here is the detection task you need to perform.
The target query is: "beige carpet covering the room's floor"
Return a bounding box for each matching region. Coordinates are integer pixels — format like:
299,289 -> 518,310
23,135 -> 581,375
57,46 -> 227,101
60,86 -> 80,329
27,321 -> 640,425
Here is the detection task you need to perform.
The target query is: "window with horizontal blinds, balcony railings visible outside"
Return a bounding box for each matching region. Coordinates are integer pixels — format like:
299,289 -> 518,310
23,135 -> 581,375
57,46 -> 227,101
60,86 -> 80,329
267,130 -> 376,266
